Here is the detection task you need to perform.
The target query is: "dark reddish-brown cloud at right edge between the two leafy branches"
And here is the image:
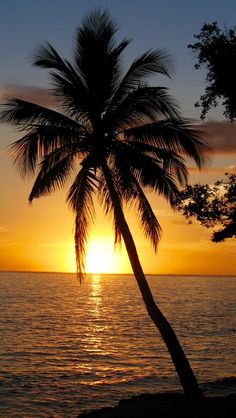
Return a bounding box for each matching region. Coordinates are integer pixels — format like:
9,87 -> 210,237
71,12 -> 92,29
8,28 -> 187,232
202,121 -> 236,154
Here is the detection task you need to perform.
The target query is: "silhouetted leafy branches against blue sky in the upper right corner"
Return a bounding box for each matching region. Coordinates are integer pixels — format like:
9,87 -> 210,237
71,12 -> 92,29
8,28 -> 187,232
188,22 -> 236,120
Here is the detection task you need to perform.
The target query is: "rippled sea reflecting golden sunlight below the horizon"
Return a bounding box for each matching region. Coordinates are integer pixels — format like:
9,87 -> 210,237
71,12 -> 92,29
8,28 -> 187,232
0,272 -> 236,418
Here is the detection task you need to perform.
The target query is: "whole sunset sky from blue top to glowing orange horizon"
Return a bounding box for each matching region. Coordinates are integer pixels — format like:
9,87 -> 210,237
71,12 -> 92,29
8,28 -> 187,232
0,0 -> 236,275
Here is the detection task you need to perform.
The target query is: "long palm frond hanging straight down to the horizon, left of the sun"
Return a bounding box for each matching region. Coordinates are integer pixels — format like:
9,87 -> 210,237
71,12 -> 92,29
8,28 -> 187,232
67,167 -> 98,279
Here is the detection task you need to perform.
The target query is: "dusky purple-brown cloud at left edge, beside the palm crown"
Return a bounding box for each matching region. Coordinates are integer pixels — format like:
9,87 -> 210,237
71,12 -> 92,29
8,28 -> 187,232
0,84 -> 56,107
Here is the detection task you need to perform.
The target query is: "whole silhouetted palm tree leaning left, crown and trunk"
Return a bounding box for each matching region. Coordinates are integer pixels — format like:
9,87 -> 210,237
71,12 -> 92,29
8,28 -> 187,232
1,11 -> 207,397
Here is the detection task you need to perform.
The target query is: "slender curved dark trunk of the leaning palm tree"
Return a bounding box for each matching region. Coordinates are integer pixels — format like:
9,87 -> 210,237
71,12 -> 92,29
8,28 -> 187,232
103,164 -> 203,398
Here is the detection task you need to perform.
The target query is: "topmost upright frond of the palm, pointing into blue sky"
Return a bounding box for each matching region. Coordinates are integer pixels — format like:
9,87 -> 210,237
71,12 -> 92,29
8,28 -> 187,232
75,11 -> 129,122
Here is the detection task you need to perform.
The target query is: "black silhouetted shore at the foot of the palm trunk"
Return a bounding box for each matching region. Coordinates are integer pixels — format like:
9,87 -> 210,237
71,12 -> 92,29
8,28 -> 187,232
78,393 -> 236,418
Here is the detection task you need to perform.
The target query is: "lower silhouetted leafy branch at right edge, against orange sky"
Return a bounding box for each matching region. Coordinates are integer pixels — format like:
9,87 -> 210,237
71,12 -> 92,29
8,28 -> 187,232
177,174 -> 236,242
